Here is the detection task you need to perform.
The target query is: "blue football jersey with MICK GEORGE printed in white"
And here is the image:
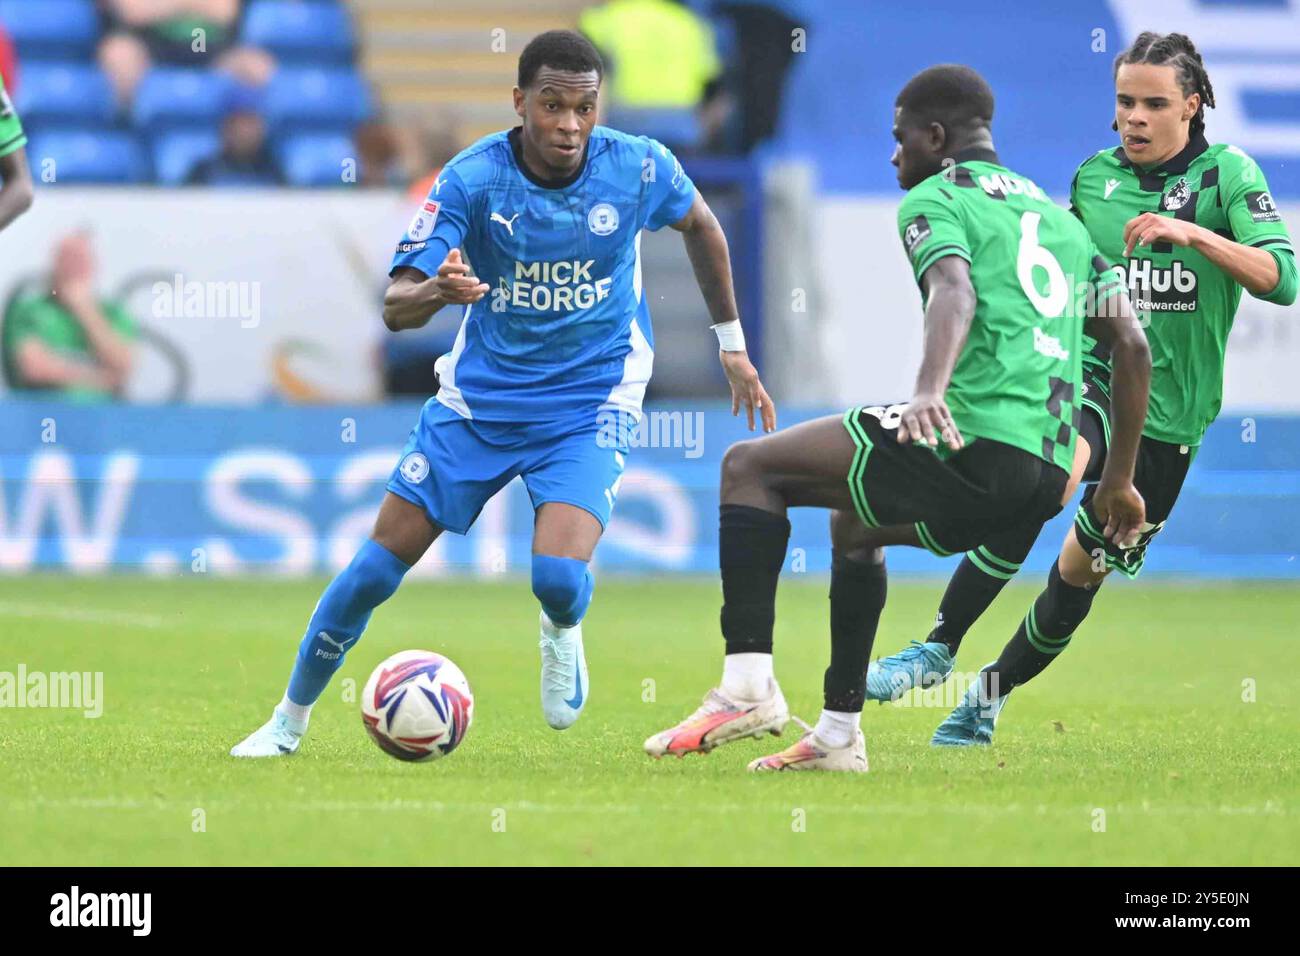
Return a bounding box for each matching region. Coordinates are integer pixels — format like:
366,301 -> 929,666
393,126 -> 696,423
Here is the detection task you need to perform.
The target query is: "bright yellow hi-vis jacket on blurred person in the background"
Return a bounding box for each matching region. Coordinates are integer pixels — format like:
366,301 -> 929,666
579,0 -> 722,118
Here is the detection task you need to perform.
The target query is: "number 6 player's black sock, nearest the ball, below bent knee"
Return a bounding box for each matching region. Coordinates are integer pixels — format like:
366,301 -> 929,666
718,505 -> 790,654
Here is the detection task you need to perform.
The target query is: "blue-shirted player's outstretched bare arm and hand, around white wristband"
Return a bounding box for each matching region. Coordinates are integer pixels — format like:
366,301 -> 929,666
672,193 -> 776,432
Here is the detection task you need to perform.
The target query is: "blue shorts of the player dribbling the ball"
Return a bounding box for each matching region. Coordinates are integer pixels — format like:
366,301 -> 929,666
387,398 -> 628,535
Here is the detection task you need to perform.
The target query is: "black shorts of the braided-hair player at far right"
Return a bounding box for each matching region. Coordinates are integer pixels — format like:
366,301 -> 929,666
1074,434 -> 1196,578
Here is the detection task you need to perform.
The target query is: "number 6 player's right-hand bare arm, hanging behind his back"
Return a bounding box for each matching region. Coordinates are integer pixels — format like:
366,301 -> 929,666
1086,273 -> 1151,546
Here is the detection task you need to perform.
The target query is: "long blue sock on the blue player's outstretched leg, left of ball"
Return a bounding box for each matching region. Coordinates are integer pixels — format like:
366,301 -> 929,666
287,538 -> 411,706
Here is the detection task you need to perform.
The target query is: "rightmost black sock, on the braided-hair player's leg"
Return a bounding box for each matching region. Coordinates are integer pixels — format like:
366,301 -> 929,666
980,563 -> 1101,700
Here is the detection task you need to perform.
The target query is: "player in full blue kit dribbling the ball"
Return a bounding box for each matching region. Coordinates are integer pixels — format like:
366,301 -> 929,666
230,30 -> 776,757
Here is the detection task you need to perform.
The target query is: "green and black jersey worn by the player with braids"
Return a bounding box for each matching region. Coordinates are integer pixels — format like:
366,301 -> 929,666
1070,135 -> 1295,446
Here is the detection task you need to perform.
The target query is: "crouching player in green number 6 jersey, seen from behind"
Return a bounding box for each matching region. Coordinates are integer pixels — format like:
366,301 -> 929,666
645,65 -> 1151,773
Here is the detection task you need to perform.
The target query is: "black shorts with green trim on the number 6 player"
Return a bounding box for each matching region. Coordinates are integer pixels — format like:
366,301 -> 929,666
844,405 -> 1070,557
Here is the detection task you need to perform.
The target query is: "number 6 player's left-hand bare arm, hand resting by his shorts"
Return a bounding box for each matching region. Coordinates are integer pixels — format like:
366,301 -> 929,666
898,256 -> 975,451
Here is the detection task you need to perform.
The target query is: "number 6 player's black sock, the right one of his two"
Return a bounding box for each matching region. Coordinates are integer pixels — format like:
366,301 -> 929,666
822,551 -> 888,714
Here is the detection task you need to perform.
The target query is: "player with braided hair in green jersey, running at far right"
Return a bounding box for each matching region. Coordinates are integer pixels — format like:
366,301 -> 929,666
867,33 -> 1296,747
